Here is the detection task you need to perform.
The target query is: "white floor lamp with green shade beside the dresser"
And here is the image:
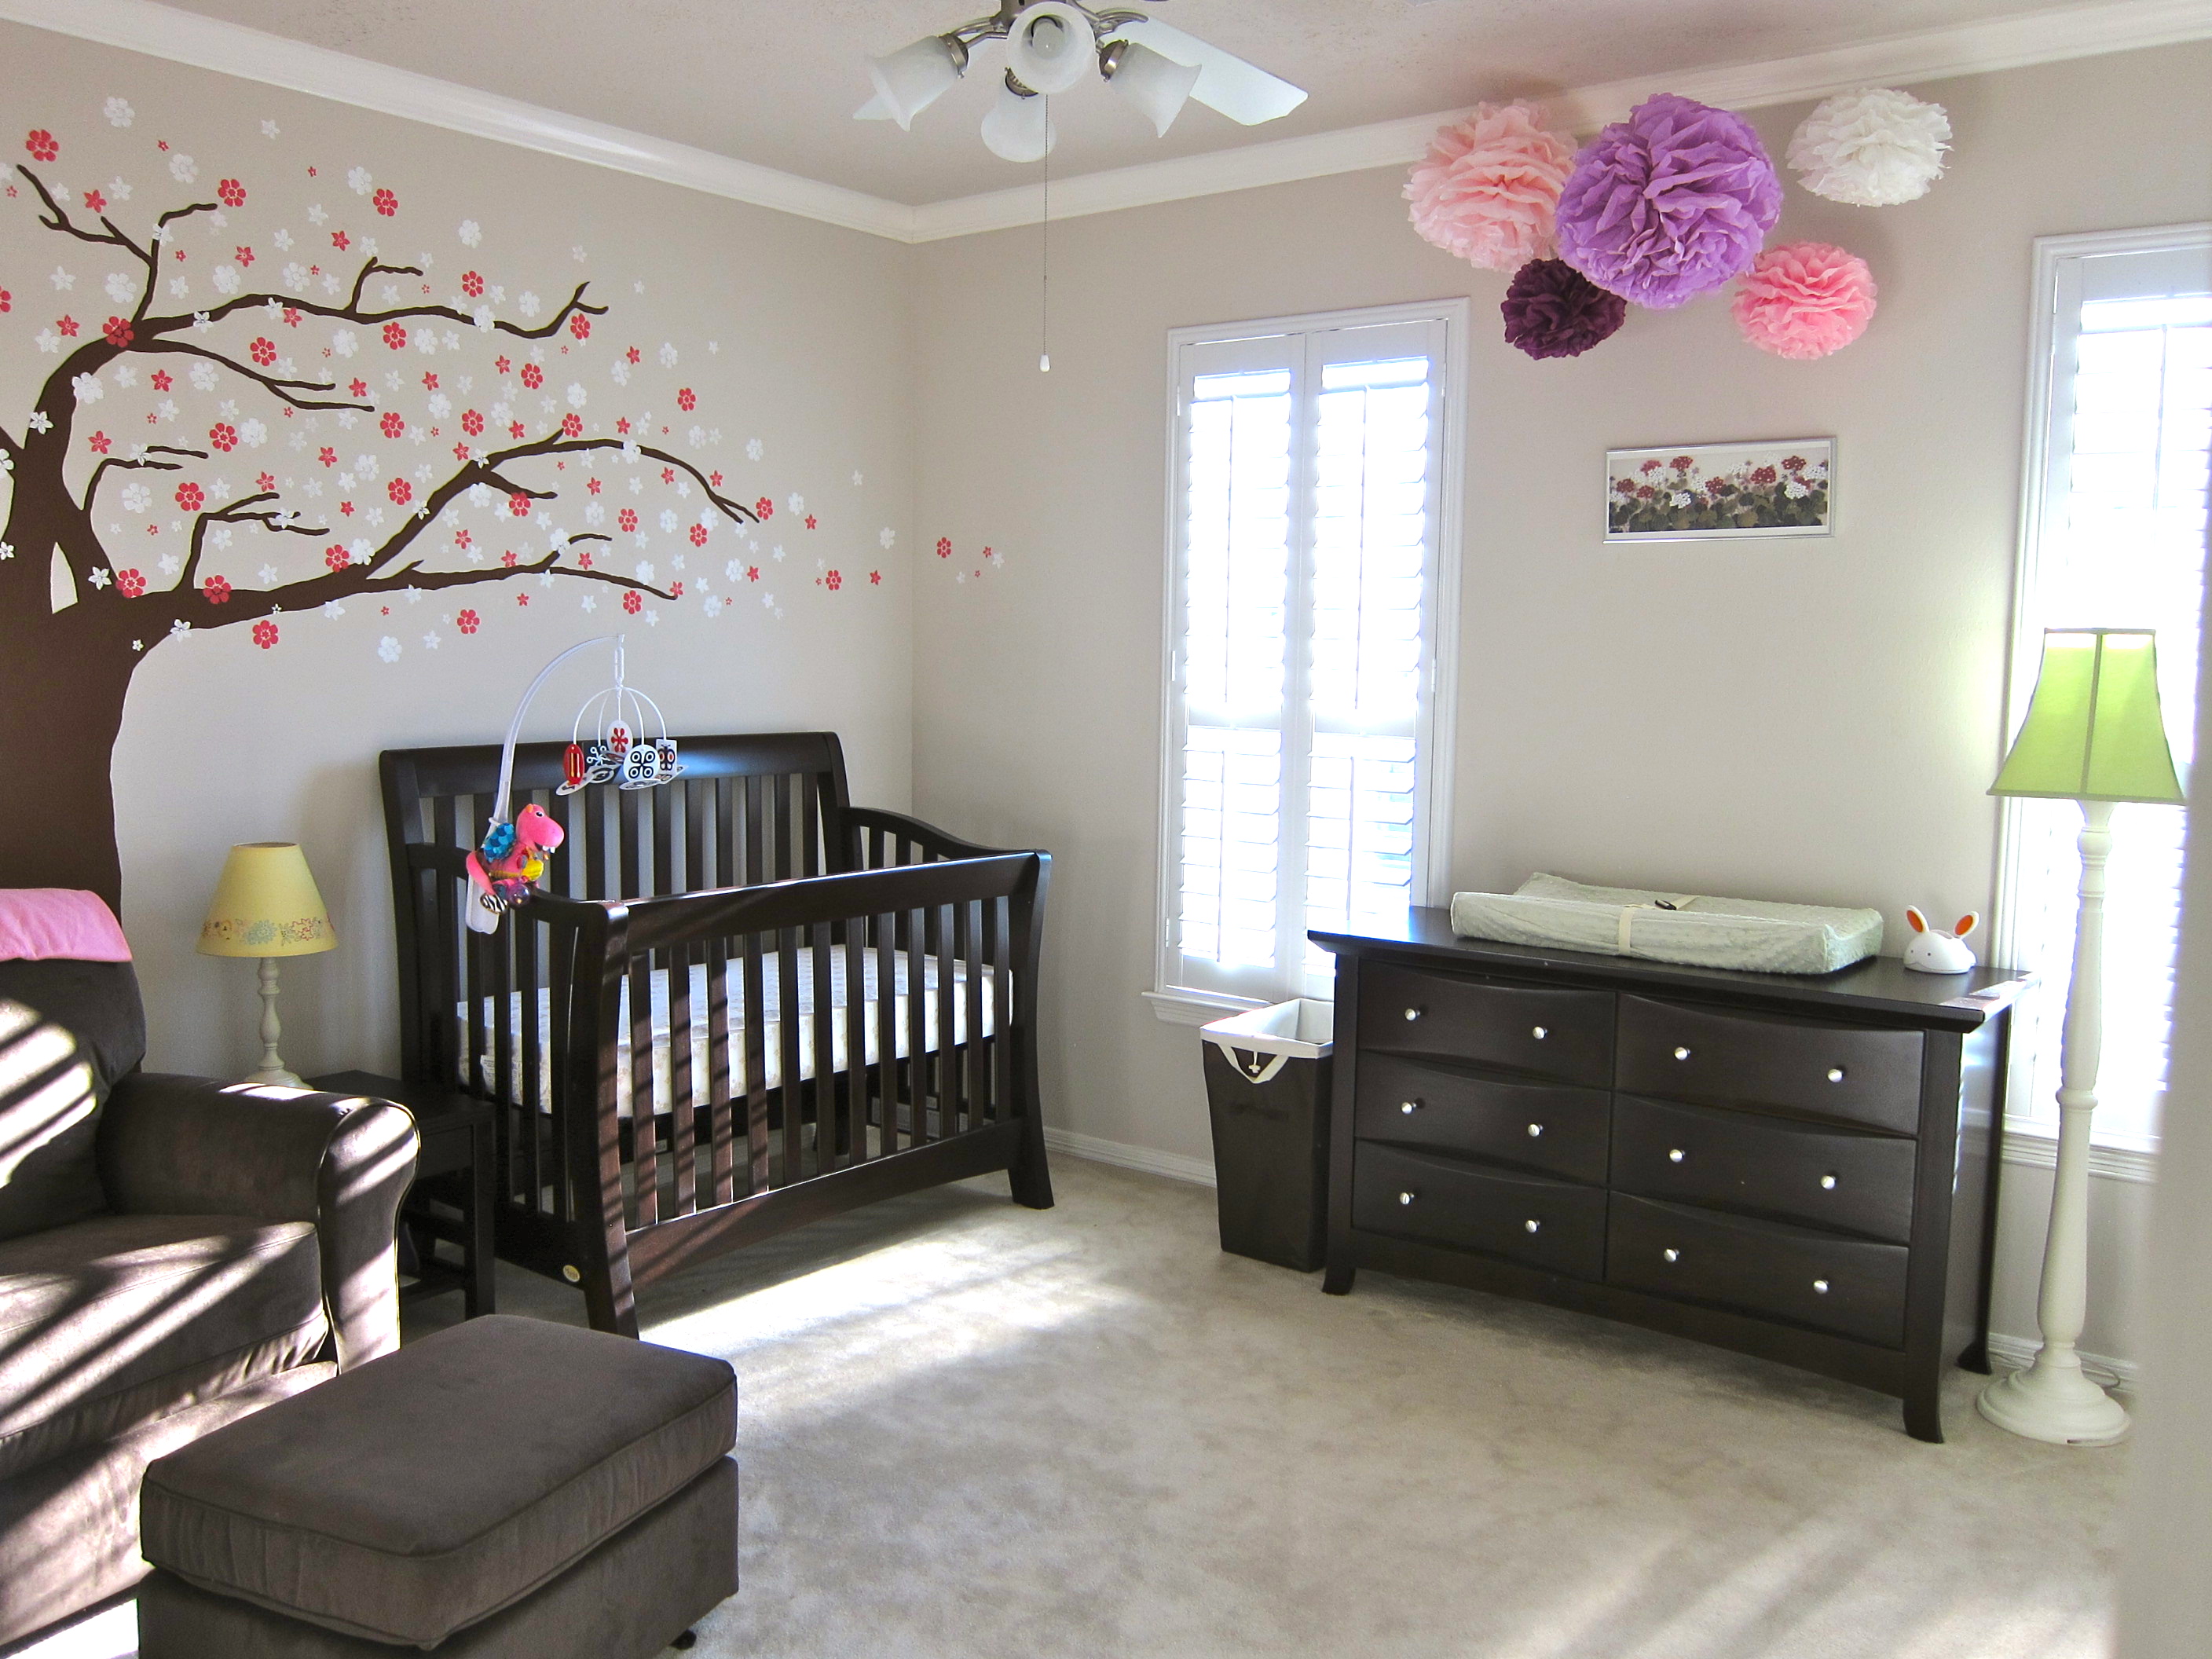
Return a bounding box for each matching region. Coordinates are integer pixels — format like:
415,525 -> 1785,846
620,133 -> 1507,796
1979,628 -> 2185,1447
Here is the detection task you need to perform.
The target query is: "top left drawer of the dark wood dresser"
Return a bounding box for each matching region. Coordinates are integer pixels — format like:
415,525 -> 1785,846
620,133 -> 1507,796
1361,965 -> 1613,1088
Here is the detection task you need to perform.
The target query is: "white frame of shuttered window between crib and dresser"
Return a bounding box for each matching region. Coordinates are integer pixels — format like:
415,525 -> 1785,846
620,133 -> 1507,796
1144,296 -> 1471,1024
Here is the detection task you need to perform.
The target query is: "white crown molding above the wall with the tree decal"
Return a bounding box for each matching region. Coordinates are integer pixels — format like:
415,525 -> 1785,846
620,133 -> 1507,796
0,0 -> 914,241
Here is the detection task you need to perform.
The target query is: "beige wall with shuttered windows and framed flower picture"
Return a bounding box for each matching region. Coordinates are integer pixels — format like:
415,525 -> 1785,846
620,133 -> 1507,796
914,46 -> 2212,1356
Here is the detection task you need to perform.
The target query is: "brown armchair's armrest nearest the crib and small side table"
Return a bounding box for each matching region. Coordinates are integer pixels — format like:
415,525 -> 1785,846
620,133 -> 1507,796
100,1071 -> 420,1372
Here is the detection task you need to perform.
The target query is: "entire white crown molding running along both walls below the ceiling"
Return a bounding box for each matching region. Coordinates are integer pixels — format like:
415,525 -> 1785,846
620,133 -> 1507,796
0,0 -> 2212,244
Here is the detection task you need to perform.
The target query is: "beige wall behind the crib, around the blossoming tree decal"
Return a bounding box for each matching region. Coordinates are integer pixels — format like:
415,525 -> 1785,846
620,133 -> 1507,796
0,24 -> 911,1073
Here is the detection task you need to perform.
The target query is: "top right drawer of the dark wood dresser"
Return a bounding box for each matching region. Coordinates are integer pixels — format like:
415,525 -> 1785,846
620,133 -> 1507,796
1615,995 -> 1925,1135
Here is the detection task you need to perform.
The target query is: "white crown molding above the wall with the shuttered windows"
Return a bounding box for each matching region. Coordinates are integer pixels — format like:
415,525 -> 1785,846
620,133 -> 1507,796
909,0 -> 2212,241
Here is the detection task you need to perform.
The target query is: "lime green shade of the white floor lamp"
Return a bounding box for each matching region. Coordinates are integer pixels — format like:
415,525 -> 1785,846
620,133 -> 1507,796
1989,628 -> 2185,805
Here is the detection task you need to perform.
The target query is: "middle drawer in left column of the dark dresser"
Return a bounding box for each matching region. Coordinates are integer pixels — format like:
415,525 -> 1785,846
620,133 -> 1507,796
1356,1055 -> 1613,1185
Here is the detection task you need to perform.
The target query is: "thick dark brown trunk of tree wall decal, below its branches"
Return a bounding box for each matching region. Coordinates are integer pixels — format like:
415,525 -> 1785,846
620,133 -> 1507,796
0,606 -> 137,914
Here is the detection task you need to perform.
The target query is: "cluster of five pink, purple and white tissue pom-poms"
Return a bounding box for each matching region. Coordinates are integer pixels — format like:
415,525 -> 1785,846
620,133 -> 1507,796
1404,89 -> 1951,358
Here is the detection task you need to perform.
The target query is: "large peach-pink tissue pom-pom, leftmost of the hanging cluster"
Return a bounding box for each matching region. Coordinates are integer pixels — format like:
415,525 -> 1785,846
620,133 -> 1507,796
1404,100 -> 1575,270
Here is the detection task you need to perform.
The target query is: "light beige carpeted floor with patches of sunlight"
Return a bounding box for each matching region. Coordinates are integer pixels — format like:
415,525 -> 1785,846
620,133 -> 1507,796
394,1157 -> 2126,1659
